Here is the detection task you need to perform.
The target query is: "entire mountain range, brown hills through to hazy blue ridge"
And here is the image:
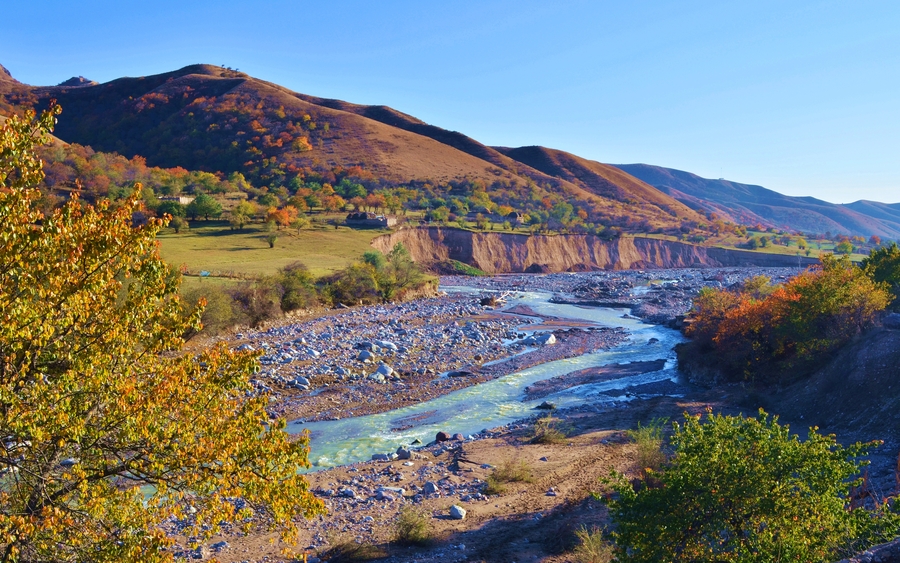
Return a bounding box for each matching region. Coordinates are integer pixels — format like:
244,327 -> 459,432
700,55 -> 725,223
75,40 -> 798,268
0,61 -> 900,238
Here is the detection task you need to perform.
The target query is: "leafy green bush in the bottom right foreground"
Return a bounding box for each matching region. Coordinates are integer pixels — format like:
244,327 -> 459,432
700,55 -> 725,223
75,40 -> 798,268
607,411 -> 900,563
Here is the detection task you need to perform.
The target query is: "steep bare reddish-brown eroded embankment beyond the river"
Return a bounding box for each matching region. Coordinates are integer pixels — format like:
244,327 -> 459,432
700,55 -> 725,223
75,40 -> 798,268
372,227 -> 818,274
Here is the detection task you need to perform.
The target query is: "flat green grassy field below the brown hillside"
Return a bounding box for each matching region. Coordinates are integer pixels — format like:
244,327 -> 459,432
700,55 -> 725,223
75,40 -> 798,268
158,221 -> 386,277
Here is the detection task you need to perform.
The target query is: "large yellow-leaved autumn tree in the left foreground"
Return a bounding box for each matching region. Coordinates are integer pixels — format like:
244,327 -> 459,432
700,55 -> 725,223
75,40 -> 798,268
0,107 -> 323,563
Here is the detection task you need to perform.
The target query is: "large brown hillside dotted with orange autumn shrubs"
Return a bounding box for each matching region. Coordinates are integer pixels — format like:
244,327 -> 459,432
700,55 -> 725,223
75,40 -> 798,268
0,65 -> 703,234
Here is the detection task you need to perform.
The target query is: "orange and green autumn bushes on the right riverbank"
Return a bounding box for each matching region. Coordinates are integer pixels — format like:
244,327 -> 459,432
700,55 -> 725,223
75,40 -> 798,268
679,256 -> 890,382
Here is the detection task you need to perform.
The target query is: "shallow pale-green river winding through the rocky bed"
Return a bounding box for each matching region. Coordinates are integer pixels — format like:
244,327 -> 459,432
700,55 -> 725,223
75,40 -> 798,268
288,287 -> 682,470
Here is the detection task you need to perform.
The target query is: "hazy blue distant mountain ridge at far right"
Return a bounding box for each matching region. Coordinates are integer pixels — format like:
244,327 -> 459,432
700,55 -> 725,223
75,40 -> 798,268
614,164 -> 900,239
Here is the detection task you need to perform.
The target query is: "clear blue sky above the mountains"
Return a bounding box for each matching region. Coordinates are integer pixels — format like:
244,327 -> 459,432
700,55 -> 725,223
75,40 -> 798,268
0,0 -> 900,203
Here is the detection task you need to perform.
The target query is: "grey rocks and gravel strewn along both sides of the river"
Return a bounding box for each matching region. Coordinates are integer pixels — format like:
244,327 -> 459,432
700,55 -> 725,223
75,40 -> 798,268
181,268 -> 799,563
